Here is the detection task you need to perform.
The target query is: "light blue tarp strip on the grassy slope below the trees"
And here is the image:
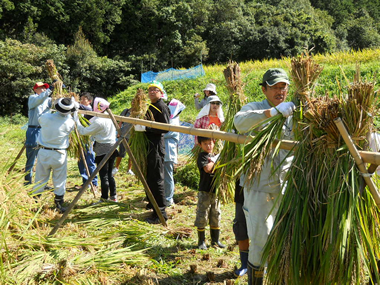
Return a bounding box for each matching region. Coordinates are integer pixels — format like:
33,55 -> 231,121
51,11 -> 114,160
141,64 -> 205,83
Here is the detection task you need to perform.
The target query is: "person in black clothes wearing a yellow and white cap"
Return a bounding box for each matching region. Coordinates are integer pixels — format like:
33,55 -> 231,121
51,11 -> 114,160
134,81 -> 170,224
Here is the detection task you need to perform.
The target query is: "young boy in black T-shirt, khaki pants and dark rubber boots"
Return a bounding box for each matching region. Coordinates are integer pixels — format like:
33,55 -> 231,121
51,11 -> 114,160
194,137 -> 225,249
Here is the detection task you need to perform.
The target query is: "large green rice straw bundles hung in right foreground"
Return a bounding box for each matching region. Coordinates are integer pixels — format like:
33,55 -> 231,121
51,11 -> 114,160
263,54 -> 380,285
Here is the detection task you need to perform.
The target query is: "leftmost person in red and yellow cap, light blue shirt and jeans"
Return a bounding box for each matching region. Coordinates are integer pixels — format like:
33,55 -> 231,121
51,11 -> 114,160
25,82 -> 54,185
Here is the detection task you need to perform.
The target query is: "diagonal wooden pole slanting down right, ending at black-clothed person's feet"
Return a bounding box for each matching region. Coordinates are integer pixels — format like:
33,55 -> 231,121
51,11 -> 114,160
107,108 -> 167,227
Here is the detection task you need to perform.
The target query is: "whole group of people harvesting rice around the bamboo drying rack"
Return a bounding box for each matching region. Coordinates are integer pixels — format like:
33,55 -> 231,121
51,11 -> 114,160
25,68 -> 294,284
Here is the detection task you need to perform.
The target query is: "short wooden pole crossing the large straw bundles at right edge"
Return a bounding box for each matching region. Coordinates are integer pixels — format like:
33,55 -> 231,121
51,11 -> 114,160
334,118 -> 380,207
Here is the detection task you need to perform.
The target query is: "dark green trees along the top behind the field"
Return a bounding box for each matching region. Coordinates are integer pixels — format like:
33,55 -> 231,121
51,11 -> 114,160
0,0 -> 380,115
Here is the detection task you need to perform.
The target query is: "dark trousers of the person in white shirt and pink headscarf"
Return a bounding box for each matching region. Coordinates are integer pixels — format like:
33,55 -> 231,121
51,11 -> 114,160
95,151 -> 117,199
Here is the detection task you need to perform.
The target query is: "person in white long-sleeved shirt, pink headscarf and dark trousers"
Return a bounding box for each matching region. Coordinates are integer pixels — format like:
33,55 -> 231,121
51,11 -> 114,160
74,98 -> 118,202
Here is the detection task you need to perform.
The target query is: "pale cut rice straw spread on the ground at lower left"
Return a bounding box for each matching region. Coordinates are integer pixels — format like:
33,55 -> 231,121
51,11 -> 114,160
0,167 -> 148,284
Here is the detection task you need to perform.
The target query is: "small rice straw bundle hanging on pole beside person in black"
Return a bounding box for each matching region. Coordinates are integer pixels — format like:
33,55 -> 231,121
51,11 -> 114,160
129,88 -> 153,177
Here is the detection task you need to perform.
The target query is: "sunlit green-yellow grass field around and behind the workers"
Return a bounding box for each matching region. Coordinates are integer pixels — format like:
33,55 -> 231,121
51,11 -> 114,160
0,47 -> 380,284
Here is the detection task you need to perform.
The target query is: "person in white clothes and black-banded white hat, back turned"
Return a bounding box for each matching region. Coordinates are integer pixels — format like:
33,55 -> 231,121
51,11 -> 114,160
33,98 -> 79,213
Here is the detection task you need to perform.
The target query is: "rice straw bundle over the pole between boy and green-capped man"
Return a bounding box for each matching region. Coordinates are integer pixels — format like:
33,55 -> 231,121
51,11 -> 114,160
213,62 -> 247,203
